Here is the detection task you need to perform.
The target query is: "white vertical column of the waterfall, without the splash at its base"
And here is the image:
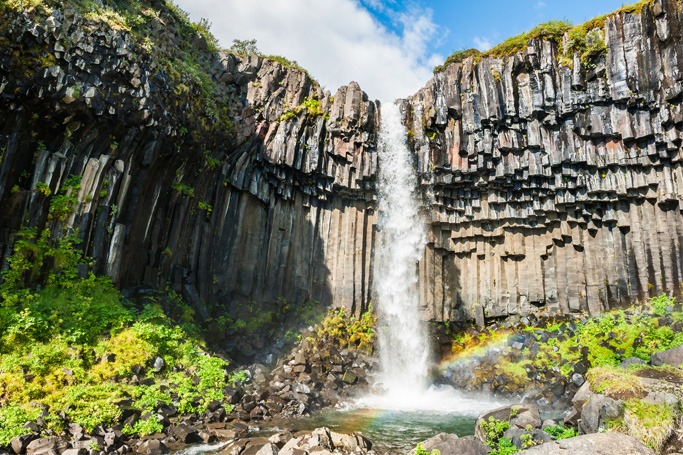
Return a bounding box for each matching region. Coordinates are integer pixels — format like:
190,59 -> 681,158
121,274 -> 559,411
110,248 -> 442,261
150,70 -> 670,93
374,103 -> 430,400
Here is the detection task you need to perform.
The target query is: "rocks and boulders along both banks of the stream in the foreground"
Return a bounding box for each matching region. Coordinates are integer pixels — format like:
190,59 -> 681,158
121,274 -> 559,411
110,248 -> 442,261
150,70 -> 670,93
5,337 -> 683,455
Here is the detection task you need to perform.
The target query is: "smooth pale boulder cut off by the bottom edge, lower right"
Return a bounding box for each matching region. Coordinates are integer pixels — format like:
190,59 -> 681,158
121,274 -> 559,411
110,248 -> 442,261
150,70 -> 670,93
524,431 -> 655,455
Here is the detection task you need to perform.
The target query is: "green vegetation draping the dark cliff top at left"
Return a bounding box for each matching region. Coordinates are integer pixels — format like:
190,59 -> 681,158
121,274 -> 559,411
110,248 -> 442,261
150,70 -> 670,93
0,0 -> 233,143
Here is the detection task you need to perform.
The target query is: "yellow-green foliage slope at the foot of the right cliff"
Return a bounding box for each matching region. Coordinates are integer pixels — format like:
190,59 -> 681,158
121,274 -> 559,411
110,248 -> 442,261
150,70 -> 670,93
448,295 -> 683,395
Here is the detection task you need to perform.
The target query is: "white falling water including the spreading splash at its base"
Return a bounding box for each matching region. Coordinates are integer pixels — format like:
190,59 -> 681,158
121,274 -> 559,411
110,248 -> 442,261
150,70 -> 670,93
351,103 -> 500,416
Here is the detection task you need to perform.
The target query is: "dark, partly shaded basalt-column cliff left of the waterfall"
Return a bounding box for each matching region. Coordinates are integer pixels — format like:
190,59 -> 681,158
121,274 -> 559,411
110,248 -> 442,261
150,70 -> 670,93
0,2 -> 379,346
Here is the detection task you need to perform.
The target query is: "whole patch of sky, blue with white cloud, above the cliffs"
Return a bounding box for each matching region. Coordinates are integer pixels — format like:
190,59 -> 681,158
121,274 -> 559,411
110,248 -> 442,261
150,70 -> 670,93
176,0 -> 624,101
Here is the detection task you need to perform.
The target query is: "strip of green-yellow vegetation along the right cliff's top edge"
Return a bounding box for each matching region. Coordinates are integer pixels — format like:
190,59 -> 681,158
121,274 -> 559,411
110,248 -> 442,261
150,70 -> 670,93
434,0 -> 654,73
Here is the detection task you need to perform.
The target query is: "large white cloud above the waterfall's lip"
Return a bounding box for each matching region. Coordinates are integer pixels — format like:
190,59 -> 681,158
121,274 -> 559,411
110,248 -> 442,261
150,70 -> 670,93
177,0 -> 443,101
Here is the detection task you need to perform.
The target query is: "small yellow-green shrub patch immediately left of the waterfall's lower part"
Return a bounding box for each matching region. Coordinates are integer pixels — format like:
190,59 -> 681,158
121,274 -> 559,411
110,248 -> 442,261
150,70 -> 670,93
317,308 -> 377,352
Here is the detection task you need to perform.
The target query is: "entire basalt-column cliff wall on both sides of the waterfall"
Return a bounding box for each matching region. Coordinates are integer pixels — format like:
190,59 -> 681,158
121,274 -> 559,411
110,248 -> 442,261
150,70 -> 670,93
0,0 -> 683,332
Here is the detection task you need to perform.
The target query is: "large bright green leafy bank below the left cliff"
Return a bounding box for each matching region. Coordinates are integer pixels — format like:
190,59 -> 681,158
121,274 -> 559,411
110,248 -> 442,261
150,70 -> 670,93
0,232 -> 240,446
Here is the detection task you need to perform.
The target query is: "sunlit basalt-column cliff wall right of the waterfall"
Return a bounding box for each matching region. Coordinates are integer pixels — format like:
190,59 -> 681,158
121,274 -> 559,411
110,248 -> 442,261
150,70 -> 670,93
405,0 -> 683,320
